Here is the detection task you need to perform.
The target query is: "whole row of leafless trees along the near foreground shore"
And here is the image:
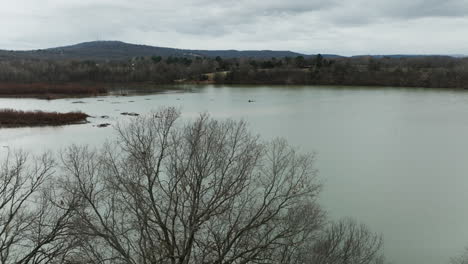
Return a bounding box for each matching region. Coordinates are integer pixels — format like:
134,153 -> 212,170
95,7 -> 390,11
0,108 -> 383,264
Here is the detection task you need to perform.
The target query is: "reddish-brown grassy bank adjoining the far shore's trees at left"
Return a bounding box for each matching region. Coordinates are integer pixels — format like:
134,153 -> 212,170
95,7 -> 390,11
0,83 -> 107,99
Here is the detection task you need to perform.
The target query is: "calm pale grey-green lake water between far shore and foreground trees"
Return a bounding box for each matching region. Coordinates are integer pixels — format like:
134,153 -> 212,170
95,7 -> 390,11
0,86 -> 468,264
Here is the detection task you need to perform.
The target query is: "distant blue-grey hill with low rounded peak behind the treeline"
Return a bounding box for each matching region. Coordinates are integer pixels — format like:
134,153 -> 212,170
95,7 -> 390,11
0,41 -> 318,60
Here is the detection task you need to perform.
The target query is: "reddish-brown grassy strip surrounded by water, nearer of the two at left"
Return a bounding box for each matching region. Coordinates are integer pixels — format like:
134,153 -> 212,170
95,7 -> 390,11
0,109 -> 88,127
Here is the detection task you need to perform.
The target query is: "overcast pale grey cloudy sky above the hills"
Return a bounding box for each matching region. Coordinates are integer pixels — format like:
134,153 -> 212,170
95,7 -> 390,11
0,0 -> 468,55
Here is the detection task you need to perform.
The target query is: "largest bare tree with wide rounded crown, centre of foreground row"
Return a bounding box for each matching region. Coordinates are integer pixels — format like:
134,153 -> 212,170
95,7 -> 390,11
62,108 -> 323,263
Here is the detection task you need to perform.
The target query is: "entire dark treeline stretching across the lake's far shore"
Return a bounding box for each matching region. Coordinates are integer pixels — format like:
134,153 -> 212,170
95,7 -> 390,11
0,55 -> 468,88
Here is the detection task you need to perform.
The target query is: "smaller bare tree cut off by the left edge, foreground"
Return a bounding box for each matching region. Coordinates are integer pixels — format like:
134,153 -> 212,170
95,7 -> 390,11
0,151 -> 77,264
